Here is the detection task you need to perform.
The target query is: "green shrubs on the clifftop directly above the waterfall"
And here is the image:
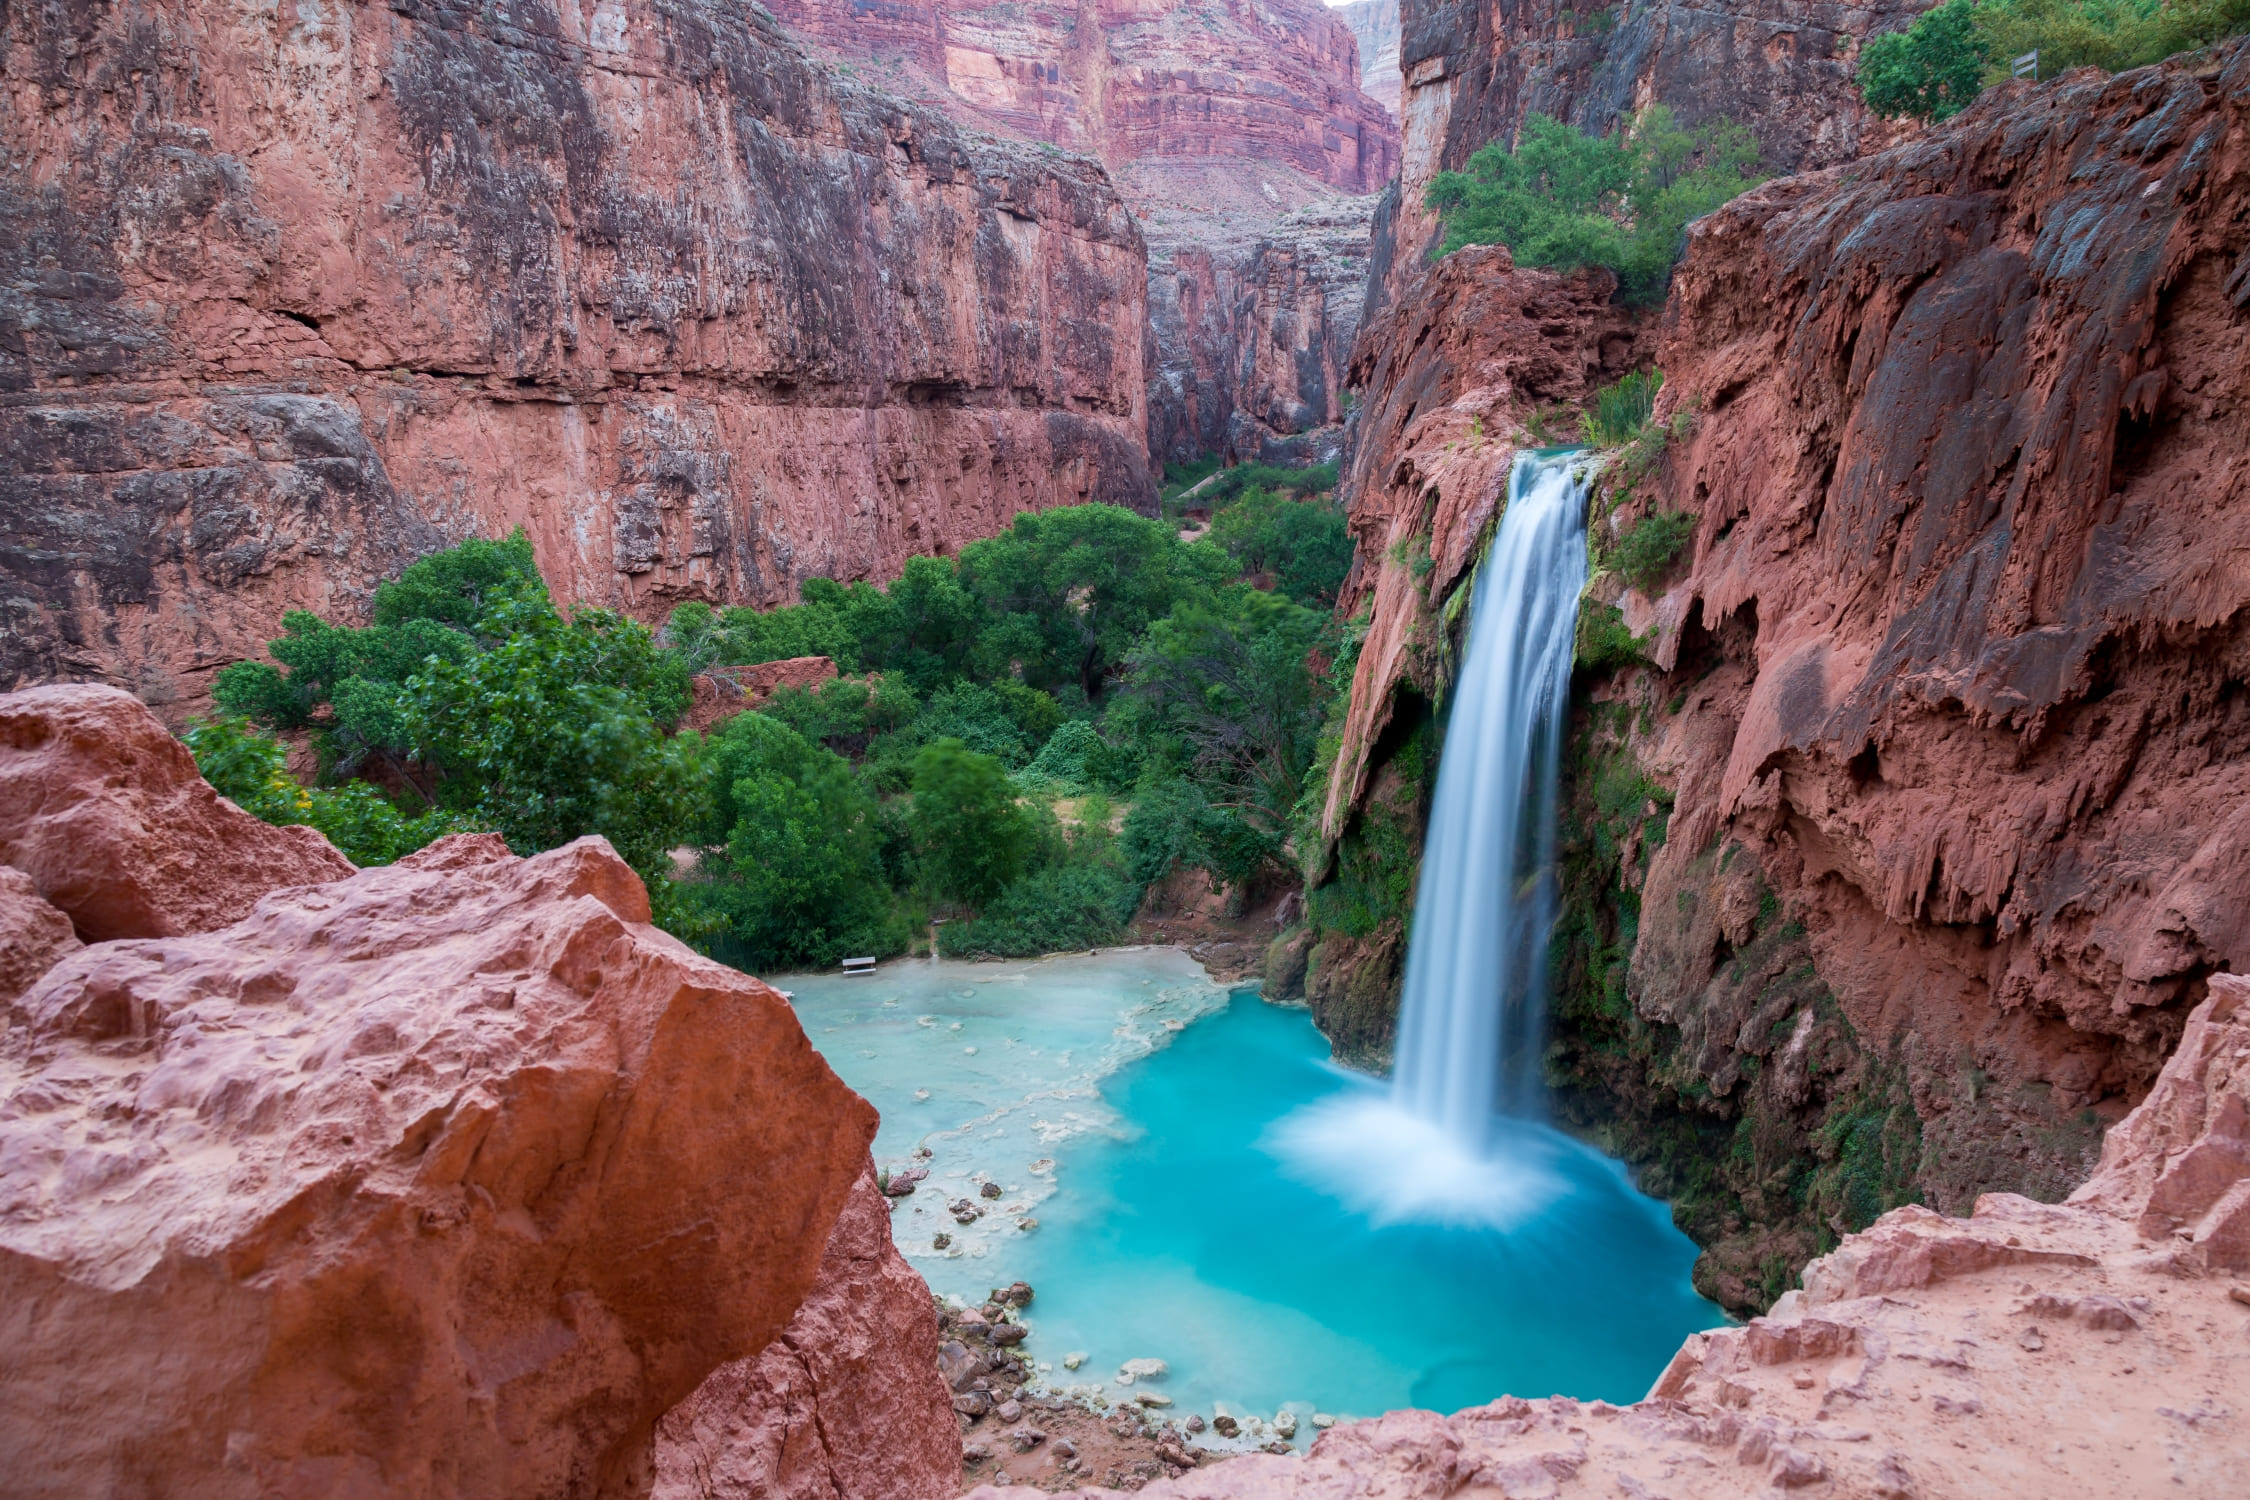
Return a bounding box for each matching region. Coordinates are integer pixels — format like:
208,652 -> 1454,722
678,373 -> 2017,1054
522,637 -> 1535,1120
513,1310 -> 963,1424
1429,103 -> 1757,301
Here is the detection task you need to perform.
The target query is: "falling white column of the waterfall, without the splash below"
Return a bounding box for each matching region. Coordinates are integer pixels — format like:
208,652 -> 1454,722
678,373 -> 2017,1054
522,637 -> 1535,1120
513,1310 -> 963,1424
1393,452 -> 1589,1151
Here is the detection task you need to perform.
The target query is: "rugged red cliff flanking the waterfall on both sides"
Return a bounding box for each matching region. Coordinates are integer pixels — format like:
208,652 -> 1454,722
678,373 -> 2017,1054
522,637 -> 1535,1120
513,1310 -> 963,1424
1307,47 -> 2250,1309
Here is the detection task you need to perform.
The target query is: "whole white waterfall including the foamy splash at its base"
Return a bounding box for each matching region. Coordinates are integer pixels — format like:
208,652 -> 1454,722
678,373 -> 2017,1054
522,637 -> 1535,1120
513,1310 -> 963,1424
1267,450 -> 1589,1228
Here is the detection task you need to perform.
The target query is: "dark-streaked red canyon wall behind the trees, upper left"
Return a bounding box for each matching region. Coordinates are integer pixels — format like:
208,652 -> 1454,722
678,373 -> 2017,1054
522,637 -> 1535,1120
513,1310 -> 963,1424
0,0 -> 1154,713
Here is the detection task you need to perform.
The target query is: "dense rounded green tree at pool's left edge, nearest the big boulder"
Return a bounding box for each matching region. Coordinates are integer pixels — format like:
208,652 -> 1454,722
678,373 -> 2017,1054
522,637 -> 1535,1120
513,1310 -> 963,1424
704,713 -> 900,969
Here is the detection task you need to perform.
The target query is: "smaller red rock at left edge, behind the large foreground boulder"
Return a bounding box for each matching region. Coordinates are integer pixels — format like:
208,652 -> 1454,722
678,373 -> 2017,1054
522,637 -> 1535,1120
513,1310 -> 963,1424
0,684 -> 353,942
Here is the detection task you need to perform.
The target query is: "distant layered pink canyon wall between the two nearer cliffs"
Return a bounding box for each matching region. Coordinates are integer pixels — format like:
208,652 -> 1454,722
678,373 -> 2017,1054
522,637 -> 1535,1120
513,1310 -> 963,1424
756,0 -> 1400,463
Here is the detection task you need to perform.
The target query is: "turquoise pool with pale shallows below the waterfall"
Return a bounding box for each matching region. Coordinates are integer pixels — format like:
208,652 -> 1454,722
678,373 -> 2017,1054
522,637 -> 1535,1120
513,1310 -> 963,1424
783,949 -> 1721,1439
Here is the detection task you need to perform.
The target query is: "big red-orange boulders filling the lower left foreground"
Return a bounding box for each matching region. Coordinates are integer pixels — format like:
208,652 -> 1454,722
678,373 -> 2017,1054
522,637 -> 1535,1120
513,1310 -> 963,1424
0,686 -> 961,1500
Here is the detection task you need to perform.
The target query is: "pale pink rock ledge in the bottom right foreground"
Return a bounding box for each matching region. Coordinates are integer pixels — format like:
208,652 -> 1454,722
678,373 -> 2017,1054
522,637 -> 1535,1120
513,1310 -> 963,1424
972,974 -> 2250,1500
